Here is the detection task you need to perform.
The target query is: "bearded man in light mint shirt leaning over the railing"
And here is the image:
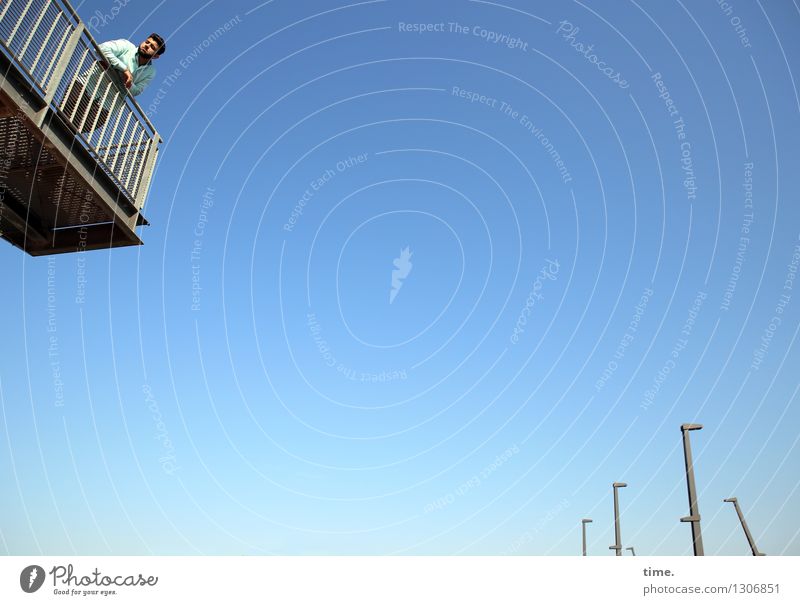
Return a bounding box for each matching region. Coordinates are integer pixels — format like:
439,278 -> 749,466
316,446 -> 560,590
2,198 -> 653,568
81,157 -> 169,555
64,34 -> 166,133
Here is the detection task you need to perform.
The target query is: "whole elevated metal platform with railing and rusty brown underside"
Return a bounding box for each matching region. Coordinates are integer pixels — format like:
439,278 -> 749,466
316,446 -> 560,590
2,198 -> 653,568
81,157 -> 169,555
0,0 -> 161,256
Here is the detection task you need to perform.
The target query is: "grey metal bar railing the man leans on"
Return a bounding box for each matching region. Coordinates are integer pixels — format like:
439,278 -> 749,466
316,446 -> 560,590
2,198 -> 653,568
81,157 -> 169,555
0,0 -> 161,210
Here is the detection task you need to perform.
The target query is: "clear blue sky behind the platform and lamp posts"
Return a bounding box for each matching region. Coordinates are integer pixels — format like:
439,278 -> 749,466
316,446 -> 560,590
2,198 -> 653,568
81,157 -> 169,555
0,0 -> 800,556
